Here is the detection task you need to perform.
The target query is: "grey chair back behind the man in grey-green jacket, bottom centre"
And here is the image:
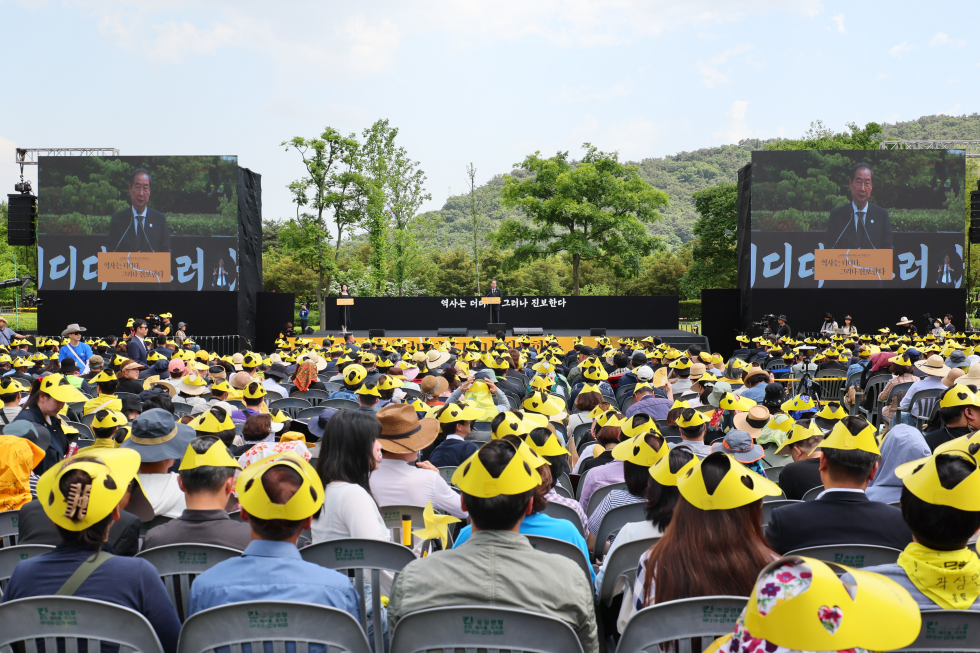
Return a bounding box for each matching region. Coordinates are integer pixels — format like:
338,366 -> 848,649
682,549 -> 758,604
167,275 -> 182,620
391,605 -> 582,653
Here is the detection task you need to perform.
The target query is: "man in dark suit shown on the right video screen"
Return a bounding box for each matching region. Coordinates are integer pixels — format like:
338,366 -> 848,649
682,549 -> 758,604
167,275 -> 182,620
824,162 -> 892,249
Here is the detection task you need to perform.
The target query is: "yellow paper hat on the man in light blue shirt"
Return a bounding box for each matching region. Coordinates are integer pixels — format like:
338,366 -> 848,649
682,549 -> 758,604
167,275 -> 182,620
237,449 -> 323,521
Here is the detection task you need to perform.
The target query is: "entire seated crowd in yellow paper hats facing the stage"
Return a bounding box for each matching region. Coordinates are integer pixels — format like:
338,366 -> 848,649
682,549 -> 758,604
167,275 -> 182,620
0,320 -> 980,653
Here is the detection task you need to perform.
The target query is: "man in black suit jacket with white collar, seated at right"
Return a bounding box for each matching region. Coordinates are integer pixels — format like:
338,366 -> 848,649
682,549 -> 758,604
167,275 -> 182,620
766,417 -> 912,555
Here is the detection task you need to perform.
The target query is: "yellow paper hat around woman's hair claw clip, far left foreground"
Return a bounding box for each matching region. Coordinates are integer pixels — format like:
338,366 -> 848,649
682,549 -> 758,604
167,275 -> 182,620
37,447 -> 140,532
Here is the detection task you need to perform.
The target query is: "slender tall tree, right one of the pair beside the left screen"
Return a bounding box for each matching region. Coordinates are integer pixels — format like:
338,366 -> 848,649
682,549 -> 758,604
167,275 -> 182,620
363,120 -> 432,297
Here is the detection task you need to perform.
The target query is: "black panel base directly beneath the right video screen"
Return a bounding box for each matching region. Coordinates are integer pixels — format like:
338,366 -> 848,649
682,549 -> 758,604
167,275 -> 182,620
752,288 -> 966,336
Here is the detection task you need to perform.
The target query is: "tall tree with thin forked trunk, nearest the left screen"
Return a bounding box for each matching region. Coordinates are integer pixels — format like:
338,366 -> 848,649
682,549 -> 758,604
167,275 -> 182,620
279,127 -> 381,315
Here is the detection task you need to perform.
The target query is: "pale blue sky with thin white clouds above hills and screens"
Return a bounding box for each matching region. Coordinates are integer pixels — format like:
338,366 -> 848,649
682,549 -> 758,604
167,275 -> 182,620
0,0 -> 980,219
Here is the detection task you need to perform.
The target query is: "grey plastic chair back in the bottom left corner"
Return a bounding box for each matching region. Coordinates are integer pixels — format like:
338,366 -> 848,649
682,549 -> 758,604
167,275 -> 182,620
0,596 -> 163,653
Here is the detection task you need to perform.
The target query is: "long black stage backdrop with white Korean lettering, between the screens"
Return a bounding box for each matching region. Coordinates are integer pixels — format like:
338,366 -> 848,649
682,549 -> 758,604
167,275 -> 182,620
318,296 -> 679,331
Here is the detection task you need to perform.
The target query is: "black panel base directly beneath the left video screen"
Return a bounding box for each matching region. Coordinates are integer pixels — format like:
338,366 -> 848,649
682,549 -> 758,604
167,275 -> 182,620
37,290 -> 238,336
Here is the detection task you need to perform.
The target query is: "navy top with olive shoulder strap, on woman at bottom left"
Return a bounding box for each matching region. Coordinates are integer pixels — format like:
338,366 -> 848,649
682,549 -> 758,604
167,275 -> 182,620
2,544 -> 180,653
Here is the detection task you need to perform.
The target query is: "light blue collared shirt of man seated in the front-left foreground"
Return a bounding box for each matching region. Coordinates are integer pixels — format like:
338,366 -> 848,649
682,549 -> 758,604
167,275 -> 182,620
188,540 -> 361,620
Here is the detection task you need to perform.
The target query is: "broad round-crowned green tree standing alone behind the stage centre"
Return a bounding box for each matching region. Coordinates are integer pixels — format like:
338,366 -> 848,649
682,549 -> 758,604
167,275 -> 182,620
497,143 -> 668,295
